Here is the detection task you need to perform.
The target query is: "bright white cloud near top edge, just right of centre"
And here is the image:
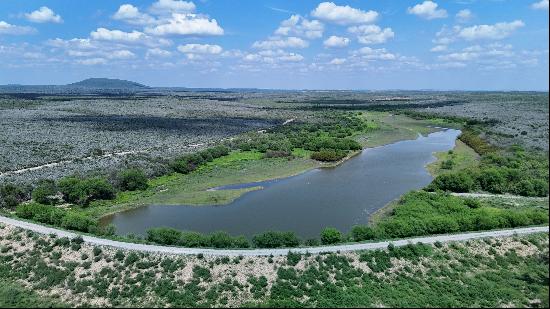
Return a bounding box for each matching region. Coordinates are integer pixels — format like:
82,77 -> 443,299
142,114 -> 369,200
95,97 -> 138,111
311,2 -> 378,25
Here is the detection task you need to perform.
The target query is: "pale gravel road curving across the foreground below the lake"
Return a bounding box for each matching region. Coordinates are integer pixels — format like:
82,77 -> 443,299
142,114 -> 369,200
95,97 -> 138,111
0,216 -> 548,256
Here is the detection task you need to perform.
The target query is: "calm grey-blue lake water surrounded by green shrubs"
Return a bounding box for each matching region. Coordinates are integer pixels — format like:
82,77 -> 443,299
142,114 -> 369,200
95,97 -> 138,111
107,129 -> 460,238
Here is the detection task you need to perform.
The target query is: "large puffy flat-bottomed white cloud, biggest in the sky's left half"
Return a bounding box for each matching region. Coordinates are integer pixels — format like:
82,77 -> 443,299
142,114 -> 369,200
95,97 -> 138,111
145,13 -> 224,36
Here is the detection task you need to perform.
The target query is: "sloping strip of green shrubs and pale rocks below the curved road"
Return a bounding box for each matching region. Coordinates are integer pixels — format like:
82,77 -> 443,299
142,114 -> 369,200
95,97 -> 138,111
0,226 -> 548,307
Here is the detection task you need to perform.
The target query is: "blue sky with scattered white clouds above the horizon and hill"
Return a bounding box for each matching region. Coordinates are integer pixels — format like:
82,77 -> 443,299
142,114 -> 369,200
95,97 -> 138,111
0,0 -> 548,91
